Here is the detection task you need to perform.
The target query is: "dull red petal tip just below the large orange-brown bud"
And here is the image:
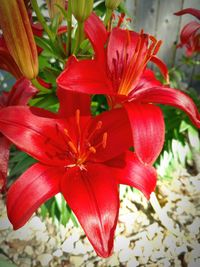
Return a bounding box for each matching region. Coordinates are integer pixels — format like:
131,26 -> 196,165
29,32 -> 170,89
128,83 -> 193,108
7,78 -> 38,106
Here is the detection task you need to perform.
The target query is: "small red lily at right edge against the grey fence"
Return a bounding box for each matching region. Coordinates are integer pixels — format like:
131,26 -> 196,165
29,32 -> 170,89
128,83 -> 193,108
174,8 -> 200,56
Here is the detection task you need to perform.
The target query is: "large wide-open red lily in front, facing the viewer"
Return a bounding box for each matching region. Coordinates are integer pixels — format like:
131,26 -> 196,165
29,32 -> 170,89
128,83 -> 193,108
0,89 -> 156,257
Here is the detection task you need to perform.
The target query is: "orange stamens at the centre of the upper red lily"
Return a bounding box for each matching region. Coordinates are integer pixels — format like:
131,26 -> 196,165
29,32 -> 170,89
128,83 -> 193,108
118,30 -> 162,95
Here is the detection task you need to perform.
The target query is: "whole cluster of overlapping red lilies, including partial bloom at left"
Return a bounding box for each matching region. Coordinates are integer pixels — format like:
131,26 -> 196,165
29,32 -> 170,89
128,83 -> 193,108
0,4 -> 200,257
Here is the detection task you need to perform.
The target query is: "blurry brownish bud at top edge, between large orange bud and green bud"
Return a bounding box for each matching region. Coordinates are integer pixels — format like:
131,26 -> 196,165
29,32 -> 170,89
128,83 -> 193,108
46,0 -> 65,23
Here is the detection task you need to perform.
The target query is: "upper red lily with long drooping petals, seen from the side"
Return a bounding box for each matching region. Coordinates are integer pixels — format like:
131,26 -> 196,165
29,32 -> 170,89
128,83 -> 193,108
57,14 -> 200,164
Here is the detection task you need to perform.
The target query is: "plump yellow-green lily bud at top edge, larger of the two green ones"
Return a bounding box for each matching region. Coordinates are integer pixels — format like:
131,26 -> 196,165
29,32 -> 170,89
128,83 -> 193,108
71,0 -> 93,22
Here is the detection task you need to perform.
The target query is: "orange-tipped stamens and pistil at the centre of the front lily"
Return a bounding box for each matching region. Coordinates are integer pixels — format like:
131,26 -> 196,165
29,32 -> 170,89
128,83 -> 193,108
64,109 -> 108,168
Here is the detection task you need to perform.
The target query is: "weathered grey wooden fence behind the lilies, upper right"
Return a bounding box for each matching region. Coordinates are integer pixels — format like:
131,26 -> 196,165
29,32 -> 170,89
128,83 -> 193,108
125,0 -> 200,90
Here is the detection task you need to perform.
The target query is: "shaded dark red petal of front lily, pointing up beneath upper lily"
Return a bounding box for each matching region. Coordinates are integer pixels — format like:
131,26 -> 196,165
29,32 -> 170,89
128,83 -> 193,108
57,88 -> 90,118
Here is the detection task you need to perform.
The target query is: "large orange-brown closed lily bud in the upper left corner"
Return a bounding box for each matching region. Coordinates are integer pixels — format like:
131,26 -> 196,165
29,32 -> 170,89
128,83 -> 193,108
0,0 -> 38,79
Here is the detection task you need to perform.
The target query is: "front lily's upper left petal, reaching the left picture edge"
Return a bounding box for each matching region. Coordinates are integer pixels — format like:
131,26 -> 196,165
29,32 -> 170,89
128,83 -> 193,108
0,106 -> 67,166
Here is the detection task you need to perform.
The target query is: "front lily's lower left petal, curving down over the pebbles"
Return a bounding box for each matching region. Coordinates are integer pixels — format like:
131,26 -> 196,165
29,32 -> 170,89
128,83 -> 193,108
6,163 -> 61,230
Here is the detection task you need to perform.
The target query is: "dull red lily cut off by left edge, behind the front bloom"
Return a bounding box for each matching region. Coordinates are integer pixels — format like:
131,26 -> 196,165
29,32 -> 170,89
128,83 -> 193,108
0,78 -> 37,192
